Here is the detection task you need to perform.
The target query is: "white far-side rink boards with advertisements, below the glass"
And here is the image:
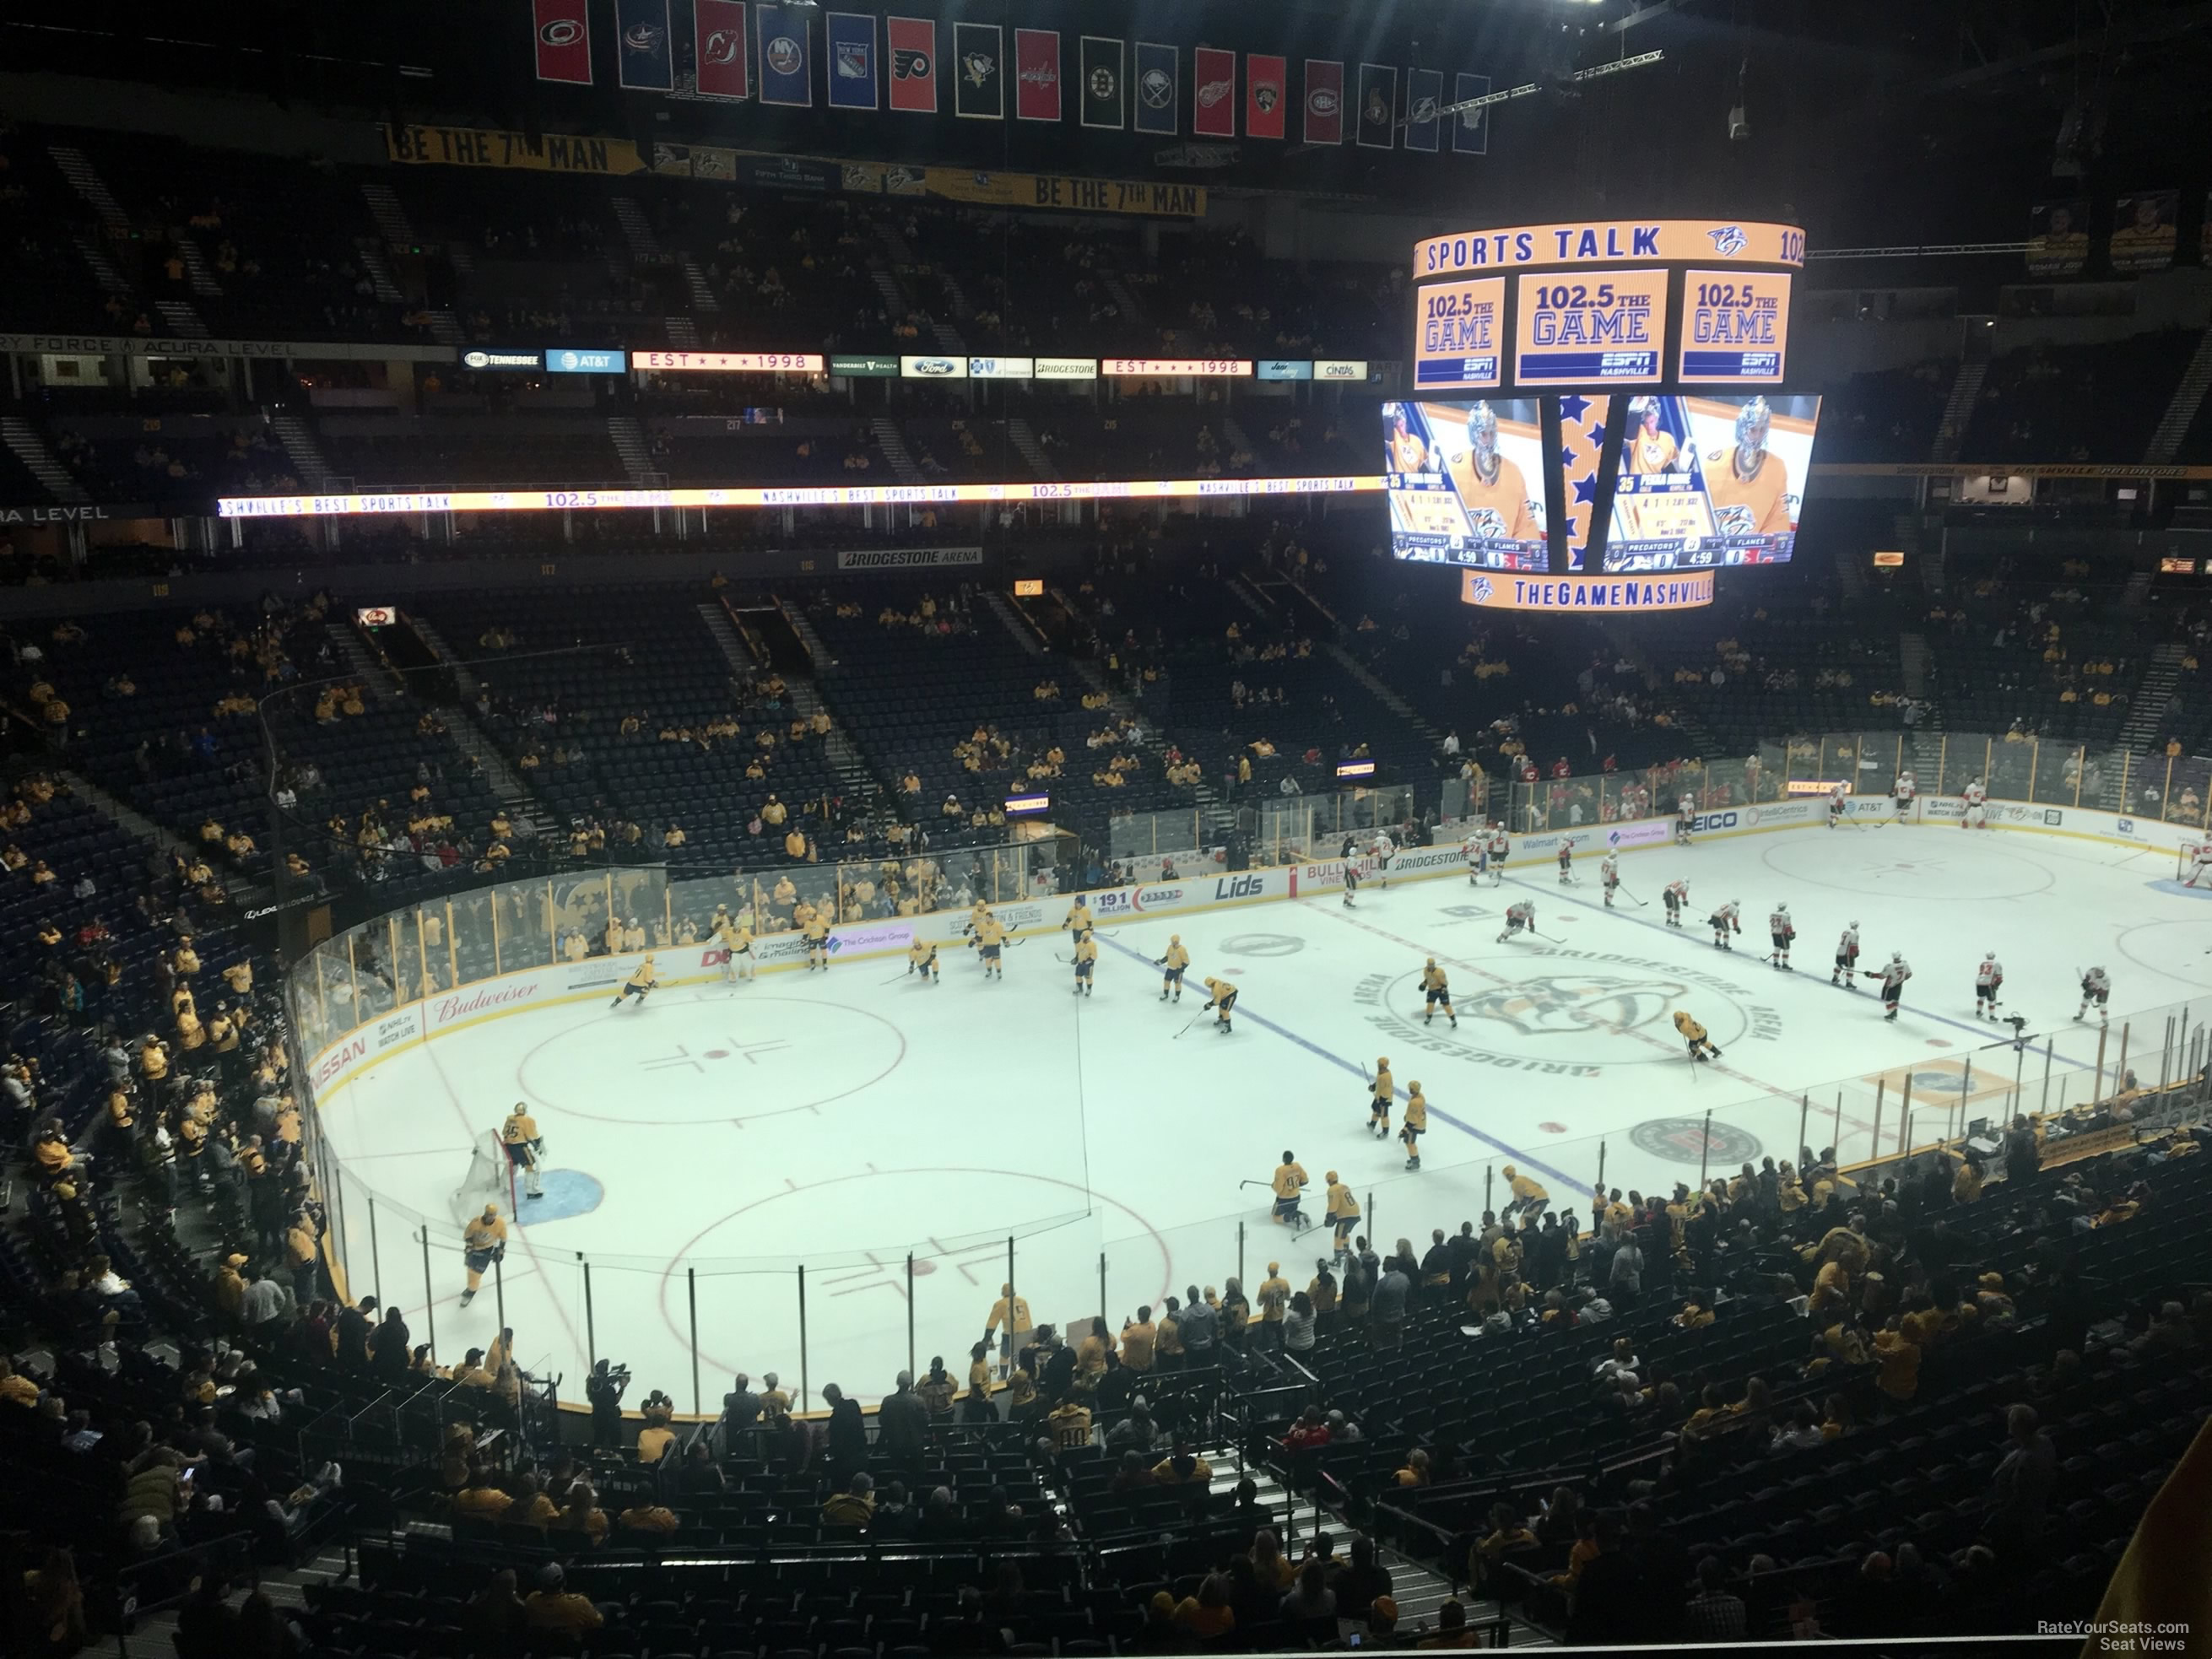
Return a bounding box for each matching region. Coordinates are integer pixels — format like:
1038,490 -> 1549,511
294,794 -> 2205,1106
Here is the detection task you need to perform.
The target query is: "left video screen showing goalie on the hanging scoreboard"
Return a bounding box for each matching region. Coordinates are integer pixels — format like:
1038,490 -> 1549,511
1382,398 -> 1546,570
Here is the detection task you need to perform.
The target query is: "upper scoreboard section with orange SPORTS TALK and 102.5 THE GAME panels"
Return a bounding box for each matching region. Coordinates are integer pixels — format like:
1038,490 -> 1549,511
1411,219 -> 1805,392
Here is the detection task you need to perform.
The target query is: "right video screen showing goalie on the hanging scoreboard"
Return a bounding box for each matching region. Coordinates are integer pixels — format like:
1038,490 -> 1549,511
1606,396 -> 1820,570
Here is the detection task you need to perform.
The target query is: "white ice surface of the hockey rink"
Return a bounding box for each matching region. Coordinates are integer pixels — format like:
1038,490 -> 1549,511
323,825 -> 2212,1411
